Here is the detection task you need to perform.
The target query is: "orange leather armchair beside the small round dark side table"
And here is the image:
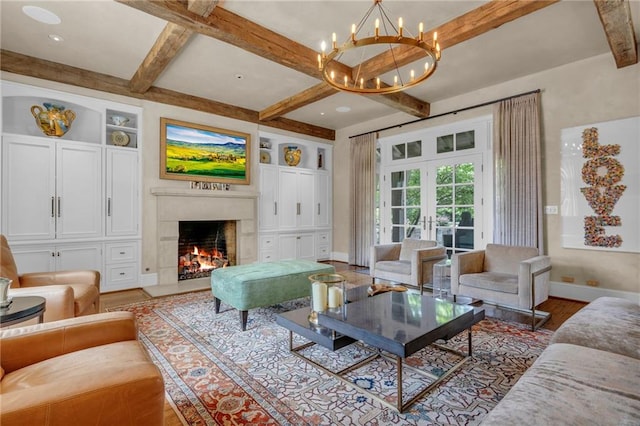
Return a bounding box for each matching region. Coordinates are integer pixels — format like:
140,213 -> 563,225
0,235 -> 100,322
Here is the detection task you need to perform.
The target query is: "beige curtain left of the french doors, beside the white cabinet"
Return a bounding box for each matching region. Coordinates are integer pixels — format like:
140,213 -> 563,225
349,133 -> 376,266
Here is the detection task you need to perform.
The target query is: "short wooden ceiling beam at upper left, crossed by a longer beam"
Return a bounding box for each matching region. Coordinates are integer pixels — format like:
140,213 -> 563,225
129,0 -> 218,93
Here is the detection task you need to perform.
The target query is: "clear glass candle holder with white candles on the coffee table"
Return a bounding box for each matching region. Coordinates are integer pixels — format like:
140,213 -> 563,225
309,274 -> 347,326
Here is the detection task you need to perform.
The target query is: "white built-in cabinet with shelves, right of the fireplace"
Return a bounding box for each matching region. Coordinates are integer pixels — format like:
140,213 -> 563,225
259,133 -> 332,262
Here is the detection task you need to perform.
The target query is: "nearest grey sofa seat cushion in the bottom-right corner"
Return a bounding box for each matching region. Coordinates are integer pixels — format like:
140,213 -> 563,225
482,343 -> 640,426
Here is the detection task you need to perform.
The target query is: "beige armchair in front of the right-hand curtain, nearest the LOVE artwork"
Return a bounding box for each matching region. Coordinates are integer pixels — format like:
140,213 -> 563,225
451,244 -> 551,329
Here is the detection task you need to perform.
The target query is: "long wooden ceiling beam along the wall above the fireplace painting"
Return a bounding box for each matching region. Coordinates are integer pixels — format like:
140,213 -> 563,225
0,49 -> 335,140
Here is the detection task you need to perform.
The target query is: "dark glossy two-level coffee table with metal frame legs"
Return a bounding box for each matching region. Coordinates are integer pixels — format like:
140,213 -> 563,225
276,292 -> 484,412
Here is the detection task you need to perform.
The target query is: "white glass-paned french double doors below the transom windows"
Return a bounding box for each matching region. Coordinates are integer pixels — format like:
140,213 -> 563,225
381,154 -> 483,254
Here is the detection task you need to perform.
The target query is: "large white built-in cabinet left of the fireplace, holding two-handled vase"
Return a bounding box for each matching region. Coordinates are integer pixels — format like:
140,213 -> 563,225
0,81 -> 142,291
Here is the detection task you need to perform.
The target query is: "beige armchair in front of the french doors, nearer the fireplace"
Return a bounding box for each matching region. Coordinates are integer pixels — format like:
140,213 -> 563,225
369,238 -> 447,293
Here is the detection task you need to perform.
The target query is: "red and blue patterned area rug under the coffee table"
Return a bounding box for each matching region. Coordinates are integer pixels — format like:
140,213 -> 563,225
111,291 -> 552,425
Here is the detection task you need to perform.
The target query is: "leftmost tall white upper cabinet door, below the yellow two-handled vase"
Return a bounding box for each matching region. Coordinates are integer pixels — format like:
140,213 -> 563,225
2,136 -> 56,241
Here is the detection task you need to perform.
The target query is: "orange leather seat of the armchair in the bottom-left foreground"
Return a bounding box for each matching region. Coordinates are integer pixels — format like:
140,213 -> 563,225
1,340 -> 164,426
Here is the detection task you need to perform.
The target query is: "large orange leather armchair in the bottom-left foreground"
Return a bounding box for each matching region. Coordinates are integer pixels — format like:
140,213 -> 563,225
0,312 -> 164,426
